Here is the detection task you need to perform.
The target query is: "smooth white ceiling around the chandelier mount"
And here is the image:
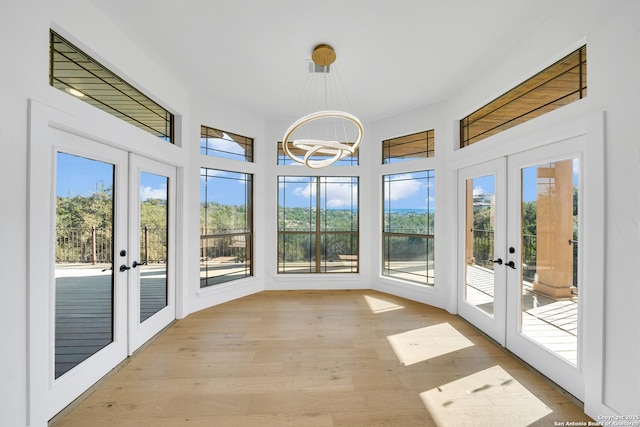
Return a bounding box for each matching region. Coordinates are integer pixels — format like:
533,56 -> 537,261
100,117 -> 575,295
92,0 -> 561,121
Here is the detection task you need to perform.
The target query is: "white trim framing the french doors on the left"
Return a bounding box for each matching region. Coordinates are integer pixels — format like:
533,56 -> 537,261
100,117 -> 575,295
27,99 -> 184,427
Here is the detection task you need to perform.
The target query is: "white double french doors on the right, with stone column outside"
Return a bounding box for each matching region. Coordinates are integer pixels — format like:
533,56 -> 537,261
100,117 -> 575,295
458,138 -> 588,400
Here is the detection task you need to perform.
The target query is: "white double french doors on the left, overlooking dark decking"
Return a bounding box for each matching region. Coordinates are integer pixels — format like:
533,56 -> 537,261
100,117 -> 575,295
32,122 -> 176,418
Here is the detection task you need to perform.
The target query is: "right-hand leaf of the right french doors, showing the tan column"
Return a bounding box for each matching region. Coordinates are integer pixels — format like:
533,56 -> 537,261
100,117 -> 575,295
505,142 -> 585,400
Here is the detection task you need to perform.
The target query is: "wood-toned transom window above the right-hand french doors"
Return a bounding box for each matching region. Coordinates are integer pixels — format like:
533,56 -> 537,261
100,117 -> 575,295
460,46 -> 587,148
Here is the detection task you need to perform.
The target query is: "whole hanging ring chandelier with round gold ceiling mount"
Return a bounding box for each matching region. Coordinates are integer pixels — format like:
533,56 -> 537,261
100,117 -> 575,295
282,44 -> 364,169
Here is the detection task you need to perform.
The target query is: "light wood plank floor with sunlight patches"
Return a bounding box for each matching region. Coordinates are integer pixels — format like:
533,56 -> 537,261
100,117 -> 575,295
53,290 -> 590,427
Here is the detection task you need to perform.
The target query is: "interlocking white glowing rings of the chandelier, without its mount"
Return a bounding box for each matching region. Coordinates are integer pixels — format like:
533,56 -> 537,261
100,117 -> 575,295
282,110 -> 364,169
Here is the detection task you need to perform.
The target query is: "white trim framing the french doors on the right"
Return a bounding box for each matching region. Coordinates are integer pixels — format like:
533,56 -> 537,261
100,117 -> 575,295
448,109 -> 613,417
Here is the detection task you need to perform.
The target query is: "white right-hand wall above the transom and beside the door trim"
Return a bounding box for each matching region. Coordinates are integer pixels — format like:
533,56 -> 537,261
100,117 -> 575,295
447,0 -> 640,416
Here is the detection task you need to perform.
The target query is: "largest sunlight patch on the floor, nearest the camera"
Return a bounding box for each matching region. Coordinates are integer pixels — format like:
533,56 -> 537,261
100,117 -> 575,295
420,365 -> 552,427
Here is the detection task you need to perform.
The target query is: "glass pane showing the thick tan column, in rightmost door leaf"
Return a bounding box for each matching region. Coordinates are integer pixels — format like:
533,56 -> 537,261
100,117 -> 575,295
521,159 -> 579,364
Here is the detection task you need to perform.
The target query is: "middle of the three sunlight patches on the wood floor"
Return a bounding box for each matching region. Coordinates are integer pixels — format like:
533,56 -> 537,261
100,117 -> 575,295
387,323 -> 473,366
